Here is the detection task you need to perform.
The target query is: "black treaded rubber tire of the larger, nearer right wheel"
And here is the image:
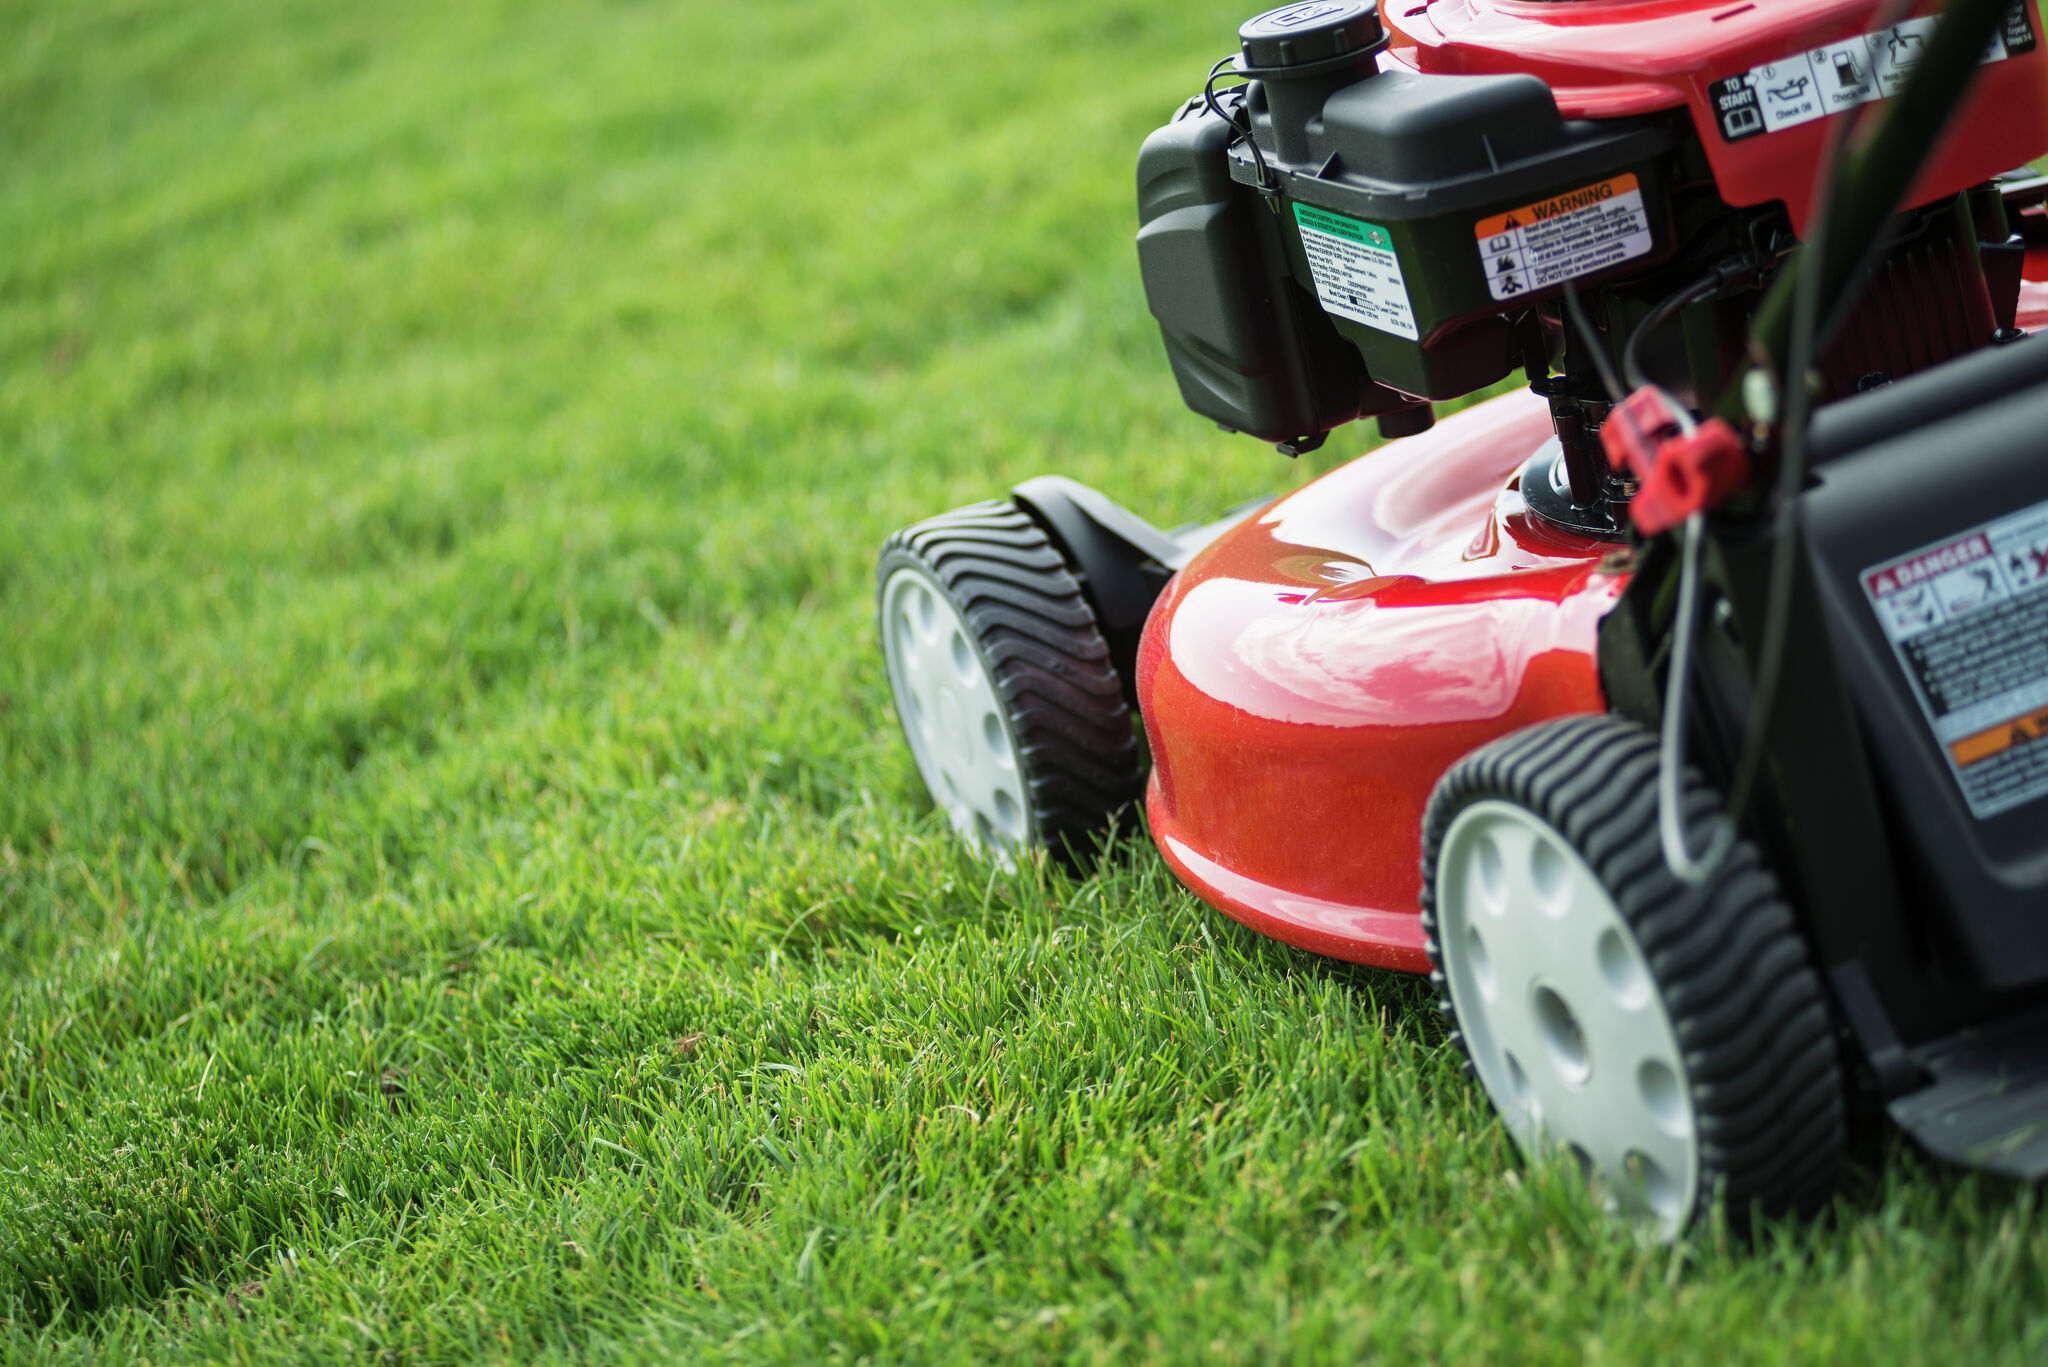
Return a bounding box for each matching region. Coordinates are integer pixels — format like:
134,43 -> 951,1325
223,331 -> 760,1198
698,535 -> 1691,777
1421,715 -> 1845,1234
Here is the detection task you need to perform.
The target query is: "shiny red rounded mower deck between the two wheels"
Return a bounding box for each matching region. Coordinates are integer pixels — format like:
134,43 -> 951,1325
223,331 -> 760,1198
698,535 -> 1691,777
1139,393 -> 1626,971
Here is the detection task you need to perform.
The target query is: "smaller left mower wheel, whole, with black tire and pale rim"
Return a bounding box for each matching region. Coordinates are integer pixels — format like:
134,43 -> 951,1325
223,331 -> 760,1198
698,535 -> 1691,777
874,502 -> 1143,853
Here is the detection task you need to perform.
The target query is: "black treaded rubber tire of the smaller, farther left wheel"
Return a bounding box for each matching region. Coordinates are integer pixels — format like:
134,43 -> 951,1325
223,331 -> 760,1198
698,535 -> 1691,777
874,500 -> 1145,861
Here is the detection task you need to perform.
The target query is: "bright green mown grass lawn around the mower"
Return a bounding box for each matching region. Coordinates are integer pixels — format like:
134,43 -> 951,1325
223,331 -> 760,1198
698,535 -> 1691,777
0,0 -> 2048,1363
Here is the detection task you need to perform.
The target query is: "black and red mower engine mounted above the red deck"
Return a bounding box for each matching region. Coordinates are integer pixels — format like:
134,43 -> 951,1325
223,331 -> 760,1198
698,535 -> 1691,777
1139,0 -> 2048,489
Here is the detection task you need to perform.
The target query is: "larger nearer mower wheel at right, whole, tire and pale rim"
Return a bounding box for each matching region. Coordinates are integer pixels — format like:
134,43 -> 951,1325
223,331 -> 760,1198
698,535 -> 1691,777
1423,715 -> 1843,1238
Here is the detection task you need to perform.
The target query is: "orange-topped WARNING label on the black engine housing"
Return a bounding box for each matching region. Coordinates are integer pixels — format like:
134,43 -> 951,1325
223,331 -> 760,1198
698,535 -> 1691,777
1473,176 -> 1651,299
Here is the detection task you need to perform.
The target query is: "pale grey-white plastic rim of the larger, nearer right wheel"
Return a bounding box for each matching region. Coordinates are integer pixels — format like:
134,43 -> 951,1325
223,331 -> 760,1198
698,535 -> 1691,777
1436,799 -> 1700,1240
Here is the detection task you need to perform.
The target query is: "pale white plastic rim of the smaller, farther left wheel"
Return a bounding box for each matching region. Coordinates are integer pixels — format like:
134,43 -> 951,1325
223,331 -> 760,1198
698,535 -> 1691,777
883,566 -> 1032,855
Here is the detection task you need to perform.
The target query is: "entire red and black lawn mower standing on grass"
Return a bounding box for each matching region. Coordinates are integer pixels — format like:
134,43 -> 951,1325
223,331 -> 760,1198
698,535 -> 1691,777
879,0 -> 2048,1238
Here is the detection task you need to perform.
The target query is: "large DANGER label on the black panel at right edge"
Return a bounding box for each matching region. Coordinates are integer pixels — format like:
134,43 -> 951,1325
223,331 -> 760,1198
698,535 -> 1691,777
1864,502 -> 2048,820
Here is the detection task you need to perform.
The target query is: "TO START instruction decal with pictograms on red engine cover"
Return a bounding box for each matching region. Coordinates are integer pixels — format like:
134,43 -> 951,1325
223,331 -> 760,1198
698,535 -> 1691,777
1706,0 -> 2036,141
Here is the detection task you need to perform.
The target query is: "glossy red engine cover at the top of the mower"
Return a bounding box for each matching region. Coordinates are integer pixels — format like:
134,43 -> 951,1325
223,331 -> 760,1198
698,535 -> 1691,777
1382,0 -> 2048,232
